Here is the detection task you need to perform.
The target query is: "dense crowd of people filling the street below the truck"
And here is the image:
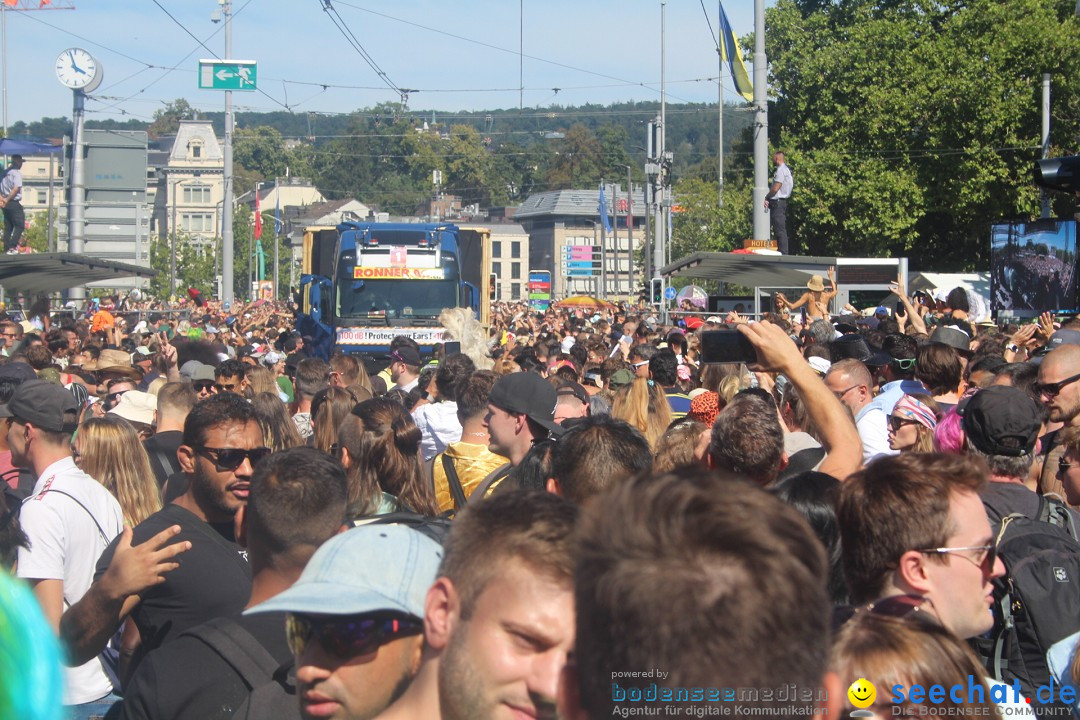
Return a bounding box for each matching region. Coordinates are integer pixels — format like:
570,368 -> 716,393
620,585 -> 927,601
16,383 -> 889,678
0,277 -> 1080,720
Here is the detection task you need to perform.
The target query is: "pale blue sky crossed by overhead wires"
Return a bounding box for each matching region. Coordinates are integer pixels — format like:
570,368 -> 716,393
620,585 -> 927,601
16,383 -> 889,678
6,0 -> 753,131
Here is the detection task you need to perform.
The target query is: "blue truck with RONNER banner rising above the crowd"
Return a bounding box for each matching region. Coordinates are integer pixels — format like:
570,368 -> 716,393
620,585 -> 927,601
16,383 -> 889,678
298,221 -> 491,365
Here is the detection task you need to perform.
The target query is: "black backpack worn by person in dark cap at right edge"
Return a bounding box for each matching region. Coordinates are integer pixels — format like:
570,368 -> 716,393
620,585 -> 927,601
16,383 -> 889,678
973,495 -> 1080,714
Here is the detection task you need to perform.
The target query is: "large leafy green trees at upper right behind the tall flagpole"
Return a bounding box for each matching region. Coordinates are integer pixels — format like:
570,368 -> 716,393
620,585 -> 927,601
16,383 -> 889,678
766,0 -> 1080,270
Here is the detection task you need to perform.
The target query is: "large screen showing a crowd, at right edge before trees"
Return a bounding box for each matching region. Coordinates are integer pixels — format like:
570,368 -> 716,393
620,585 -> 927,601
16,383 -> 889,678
990,219 -> 1077,317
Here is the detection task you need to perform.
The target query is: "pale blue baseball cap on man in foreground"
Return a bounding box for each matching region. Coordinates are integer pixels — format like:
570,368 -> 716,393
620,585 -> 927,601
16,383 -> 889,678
247,525 -> 443,617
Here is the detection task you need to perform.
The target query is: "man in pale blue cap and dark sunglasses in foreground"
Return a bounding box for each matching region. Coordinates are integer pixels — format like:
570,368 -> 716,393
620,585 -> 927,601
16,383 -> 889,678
243,525 -> 443,720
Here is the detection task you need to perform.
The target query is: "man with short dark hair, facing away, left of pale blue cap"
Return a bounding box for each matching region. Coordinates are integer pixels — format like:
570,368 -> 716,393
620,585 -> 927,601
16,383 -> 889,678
121,447 -> 349,720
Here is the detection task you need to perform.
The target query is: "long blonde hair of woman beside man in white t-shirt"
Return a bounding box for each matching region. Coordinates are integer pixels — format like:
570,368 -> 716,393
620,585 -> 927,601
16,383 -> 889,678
76,415 -> 161,527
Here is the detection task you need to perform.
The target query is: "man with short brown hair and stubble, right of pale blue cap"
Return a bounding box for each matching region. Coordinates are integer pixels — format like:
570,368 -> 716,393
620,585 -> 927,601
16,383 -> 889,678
375,491 -> 578,720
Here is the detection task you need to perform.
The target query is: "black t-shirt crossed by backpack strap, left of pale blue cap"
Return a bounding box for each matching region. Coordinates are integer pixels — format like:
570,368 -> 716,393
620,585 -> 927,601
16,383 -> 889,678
120,612 -> 295,720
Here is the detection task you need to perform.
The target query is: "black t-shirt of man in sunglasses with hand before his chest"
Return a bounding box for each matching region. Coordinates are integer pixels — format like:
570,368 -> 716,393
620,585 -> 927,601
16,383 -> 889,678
94,504 -> 252,670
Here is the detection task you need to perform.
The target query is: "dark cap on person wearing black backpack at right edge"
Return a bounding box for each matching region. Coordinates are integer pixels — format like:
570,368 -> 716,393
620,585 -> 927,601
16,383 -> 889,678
963,385 -> 1042,457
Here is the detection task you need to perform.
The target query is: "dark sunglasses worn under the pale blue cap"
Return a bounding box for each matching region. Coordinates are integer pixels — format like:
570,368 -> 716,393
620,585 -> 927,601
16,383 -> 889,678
285,612 -> 423,658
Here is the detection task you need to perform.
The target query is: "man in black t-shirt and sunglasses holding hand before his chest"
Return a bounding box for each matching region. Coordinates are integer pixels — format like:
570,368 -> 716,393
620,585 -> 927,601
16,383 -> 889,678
62,393 -> 270,679
